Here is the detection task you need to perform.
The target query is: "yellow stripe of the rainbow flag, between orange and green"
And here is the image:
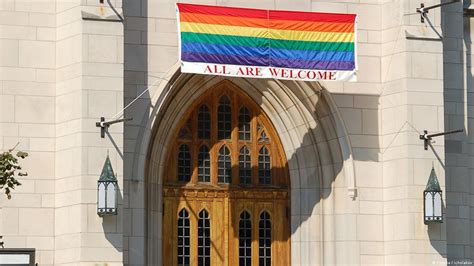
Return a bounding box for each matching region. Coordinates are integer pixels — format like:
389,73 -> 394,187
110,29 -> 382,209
180,22 -> 354,42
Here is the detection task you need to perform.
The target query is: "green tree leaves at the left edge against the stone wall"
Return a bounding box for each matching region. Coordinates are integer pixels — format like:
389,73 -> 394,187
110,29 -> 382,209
0,149 -> 28,199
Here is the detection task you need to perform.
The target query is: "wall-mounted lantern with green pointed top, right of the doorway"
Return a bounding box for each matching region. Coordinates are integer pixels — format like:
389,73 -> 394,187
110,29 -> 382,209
423,167 -> 443,224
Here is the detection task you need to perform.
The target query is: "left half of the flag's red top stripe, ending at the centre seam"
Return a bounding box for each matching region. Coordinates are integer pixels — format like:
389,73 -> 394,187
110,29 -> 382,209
177,3 -> 268,19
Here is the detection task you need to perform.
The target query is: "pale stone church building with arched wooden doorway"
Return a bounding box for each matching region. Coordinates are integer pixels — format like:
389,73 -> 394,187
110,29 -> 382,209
0,0 -> 474,265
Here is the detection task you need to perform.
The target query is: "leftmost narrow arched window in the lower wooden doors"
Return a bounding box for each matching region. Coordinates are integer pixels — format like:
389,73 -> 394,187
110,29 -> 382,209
178,209 -> 191,266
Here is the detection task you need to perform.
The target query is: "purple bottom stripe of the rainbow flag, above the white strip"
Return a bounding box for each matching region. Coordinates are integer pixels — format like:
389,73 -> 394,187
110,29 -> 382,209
181,52 -> 355,70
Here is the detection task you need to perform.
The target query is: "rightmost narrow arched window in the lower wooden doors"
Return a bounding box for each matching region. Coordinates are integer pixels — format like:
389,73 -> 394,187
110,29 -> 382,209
258,211 -> 272,266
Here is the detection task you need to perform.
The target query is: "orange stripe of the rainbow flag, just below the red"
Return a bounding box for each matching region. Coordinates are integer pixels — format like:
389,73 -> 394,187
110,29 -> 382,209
179,13 -> 354,32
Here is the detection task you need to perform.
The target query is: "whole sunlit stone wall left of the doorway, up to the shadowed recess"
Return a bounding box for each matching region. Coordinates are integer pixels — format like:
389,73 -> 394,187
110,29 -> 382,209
0,0 -> 123,265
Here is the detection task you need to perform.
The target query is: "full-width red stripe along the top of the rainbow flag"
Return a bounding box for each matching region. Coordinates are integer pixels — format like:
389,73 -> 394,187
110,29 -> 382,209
177,3 -> 356,23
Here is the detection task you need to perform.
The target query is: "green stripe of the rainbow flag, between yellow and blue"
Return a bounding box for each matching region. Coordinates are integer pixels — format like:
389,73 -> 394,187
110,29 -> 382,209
181,32 -> 354,52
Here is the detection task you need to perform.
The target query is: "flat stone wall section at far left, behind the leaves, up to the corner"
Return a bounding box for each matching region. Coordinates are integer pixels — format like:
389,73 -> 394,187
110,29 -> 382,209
0,0 -> 56,265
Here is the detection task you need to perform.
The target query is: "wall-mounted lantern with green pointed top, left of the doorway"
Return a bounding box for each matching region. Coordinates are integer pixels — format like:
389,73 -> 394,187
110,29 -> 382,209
97,155 -> 118,216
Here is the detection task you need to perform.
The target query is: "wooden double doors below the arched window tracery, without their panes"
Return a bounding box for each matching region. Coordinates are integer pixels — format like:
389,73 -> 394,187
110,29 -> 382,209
163,193 -> 290,266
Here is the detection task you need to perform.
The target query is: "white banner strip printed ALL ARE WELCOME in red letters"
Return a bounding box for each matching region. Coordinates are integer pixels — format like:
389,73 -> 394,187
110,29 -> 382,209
181,61 -> 357,81
